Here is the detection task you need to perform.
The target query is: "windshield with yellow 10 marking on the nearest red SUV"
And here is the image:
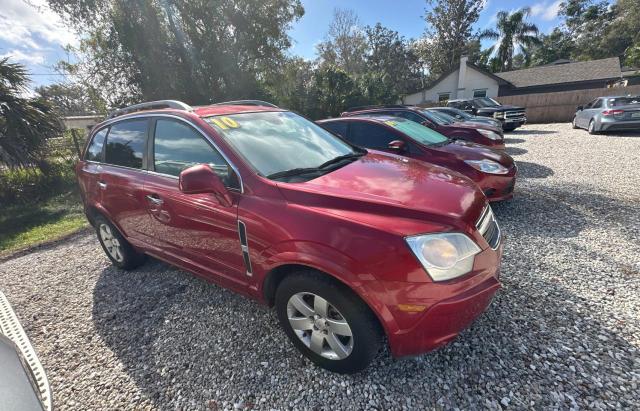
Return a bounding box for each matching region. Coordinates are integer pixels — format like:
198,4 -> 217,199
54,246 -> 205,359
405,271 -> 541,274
205,111 -> 364,179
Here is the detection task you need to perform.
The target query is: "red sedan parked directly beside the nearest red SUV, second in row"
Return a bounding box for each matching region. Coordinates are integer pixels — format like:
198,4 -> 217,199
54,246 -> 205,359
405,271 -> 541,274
318,116 -> 517,201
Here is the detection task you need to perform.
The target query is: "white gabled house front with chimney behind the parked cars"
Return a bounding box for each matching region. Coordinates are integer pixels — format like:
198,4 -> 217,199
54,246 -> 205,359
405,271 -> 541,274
403,56 -> 505,104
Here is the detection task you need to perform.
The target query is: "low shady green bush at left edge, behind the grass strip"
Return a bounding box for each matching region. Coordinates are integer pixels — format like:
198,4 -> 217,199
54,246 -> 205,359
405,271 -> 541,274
0,160 -> 77,206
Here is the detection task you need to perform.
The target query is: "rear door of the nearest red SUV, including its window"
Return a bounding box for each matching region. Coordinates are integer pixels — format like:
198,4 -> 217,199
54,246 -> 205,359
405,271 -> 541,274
98,118 -> 150,242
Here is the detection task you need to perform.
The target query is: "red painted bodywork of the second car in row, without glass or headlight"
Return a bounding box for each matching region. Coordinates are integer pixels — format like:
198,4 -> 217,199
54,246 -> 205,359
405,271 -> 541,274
317,117 -> 517,201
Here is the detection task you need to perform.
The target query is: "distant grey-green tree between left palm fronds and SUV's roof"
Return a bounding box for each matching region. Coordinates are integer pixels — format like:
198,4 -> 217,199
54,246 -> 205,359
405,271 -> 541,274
35,83 -> 107,116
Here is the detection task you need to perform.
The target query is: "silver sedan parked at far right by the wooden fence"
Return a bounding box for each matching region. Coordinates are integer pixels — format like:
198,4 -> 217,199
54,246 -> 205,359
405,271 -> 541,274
573,96 -> 640,134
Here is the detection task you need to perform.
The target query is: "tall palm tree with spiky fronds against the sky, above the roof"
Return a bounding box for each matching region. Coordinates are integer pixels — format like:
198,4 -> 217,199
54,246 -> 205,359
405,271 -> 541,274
478,7 -> 541,70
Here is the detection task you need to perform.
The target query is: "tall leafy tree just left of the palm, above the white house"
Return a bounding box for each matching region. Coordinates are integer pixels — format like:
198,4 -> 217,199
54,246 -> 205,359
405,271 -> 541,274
417,0 -> 485,79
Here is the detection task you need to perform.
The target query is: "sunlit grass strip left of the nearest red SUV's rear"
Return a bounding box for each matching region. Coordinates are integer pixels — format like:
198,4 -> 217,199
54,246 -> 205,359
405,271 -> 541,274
0,190 -> 89,256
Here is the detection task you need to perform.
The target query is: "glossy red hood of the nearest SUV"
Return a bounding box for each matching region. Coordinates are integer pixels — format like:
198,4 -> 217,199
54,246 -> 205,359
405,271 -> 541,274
278,150 -> 486,230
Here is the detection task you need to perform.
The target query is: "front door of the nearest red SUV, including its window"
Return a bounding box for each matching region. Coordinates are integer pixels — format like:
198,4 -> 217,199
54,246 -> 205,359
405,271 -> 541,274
144,117 -> 248,286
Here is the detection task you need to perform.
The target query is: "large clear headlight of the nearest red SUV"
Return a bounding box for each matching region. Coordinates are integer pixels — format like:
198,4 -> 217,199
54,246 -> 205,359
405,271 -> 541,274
406,233 -> 481,281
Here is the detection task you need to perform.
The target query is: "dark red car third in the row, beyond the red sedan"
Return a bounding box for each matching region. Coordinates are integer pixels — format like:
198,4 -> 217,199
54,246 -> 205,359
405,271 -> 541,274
340,105 -> 505,150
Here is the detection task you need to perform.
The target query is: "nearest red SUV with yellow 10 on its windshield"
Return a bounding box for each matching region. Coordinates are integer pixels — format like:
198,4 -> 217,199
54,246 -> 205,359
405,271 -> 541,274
76,101 -> 502,372
